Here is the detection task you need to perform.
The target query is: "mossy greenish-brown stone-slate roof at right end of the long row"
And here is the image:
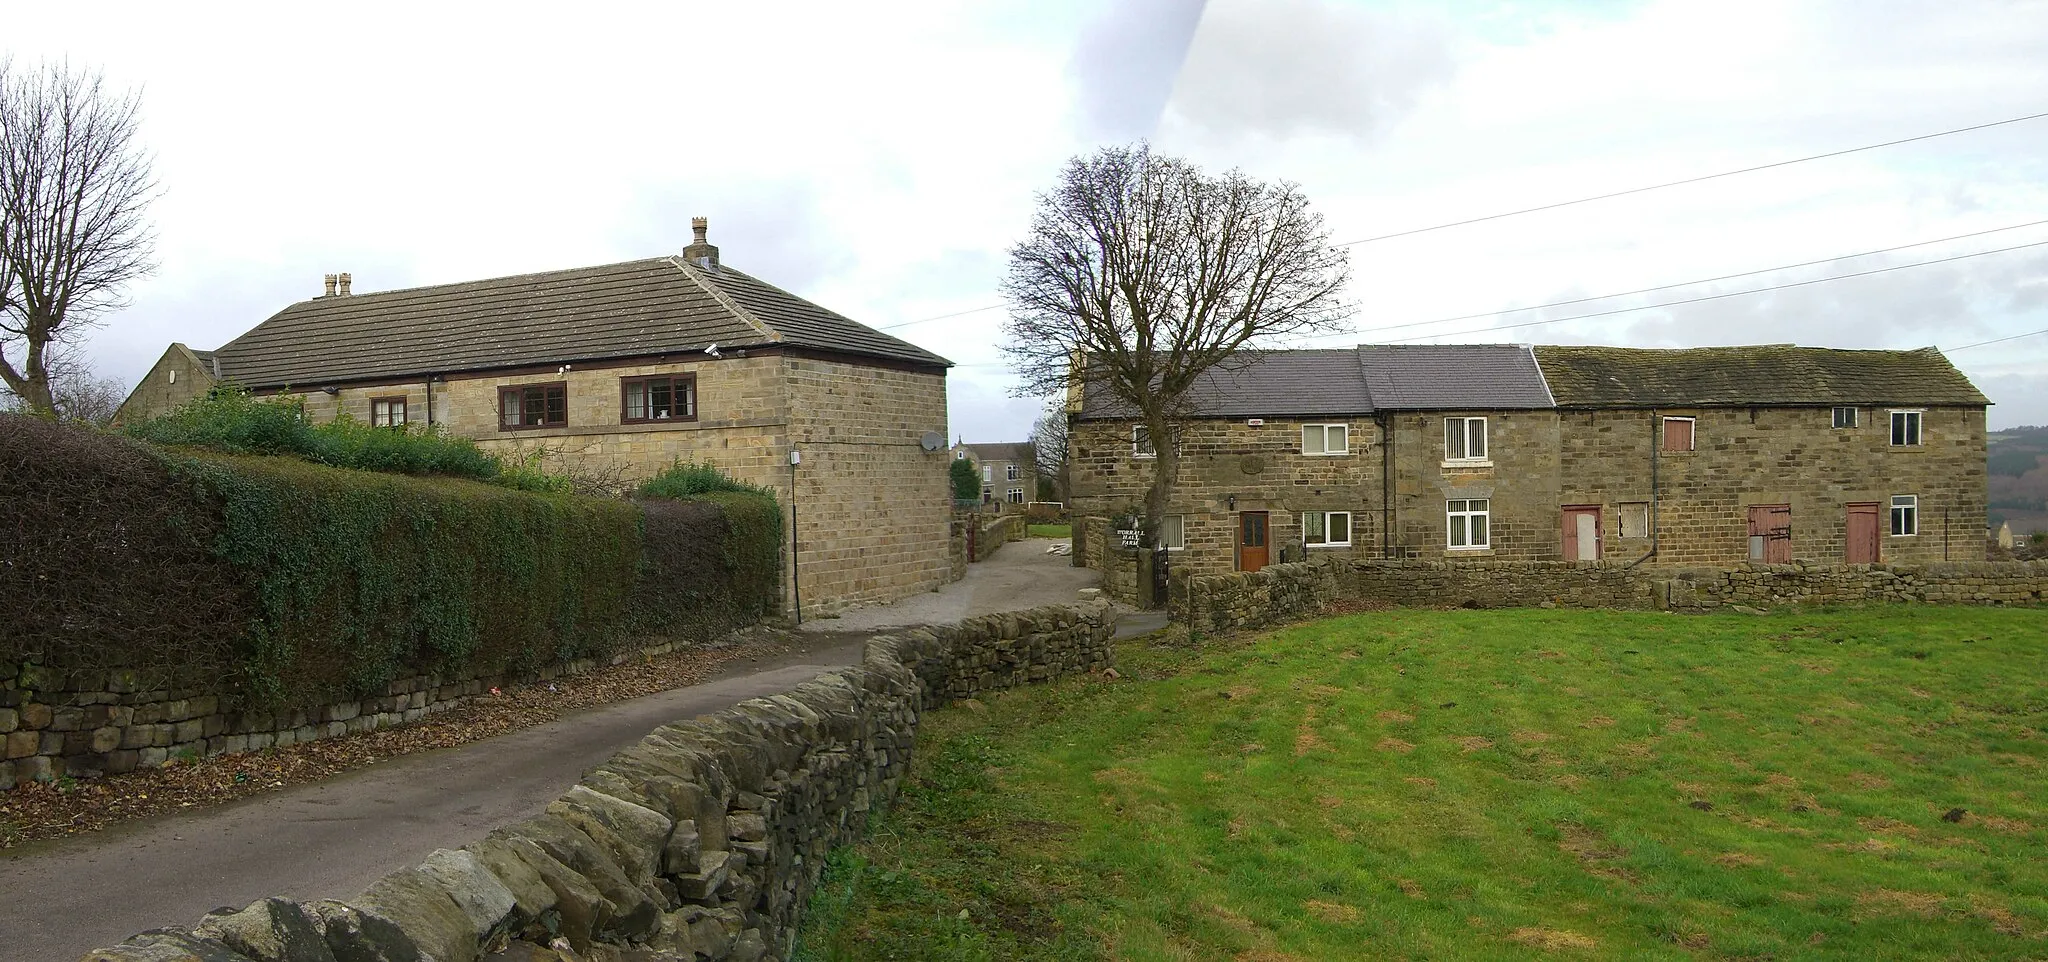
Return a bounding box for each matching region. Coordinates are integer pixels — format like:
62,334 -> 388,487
1536,344 -> 1989,407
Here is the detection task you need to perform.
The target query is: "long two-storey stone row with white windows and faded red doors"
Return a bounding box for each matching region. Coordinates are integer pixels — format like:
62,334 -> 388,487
1069,344 -> 1987,581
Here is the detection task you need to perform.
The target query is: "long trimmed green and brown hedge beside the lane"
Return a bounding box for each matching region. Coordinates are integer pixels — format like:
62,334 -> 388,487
0,418 -> 780,708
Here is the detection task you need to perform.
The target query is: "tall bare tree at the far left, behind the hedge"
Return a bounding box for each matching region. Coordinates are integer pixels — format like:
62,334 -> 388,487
0,59 -> 156,416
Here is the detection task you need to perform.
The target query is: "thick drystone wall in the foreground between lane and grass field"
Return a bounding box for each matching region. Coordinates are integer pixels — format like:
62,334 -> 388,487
86,606 -> 1112,962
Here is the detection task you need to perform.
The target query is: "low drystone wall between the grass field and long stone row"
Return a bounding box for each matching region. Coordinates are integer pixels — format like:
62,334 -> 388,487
1169,561 -> 2048,630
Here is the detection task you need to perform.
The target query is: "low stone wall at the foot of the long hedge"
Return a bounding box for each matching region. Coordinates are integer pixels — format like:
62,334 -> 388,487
0,643 -> 690,792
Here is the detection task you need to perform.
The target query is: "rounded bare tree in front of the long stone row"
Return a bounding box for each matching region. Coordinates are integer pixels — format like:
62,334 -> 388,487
1004,143 -> 1350,544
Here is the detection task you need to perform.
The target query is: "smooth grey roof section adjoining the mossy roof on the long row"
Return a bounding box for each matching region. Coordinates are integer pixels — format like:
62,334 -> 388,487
1358,344 -> 1552,411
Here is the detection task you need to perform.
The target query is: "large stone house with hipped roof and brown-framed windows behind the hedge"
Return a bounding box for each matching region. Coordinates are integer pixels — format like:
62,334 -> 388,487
119,217 -> 952,610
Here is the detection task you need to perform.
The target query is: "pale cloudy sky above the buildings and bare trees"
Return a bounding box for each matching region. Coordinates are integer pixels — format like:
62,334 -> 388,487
0,0 -> 2048,440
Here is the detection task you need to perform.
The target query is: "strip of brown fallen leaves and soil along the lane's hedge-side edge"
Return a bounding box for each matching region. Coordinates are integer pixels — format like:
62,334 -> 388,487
0,632 -> 788,849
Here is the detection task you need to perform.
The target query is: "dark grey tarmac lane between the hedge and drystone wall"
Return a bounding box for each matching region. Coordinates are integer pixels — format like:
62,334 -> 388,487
0,637 -> 864,962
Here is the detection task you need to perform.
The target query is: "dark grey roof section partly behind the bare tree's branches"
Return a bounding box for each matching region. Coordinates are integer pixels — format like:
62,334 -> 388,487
1081,348 -> 1372,420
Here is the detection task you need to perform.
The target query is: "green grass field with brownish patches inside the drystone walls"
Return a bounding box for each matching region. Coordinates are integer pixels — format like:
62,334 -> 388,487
797,606 -> 2048,962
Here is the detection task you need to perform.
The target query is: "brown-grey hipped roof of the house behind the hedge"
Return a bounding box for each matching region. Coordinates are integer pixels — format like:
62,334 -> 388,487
213,258 -> 950,387
